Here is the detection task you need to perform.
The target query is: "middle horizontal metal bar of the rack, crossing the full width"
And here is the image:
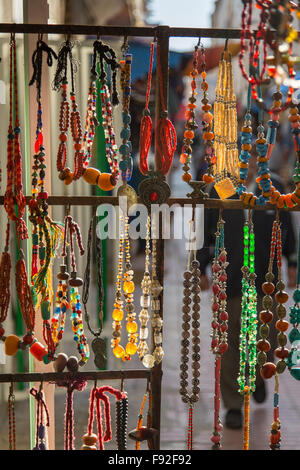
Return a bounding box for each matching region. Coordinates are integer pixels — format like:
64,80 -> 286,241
0,196 -> 300,212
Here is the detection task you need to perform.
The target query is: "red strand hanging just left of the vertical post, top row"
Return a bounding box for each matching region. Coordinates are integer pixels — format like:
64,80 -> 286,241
139,42 -> 154,175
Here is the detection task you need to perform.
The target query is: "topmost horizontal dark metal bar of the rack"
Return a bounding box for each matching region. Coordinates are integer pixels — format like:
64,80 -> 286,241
0,23 -> 280,39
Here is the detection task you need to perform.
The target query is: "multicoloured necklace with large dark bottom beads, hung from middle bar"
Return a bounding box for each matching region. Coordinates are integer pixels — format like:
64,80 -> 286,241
51,215 -> 90,372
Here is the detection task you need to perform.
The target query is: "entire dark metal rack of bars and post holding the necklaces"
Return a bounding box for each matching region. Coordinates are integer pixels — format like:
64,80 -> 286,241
0,23 -> 300,450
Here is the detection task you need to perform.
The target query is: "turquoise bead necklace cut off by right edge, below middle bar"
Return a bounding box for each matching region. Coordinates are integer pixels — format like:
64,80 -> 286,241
286,230 -> 300,380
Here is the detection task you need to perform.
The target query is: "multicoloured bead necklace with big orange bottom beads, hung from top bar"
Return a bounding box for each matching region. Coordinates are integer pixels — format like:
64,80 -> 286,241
83,40 -> 119,191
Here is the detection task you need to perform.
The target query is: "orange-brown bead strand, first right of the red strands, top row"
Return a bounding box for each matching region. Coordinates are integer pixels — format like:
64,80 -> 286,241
180,45 -> 198,183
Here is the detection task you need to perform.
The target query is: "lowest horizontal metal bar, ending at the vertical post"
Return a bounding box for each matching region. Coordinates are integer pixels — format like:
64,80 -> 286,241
0,369 -> 151,383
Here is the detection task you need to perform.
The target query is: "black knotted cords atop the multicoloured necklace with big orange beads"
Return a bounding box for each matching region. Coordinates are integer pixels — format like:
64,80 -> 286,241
91,39 -> 119,106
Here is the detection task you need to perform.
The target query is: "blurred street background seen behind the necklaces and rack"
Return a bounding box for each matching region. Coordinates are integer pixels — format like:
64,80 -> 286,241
0,0 -> 300,449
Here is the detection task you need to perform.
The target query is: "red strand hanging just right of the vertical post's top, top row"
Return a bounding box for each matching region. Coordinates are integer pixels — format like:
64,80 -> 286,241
155,46 -> 177,175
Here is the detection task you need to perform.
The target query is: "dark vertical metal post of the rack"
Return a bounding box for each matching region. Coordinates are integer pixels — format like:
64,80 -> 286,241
151,26 -> 169,450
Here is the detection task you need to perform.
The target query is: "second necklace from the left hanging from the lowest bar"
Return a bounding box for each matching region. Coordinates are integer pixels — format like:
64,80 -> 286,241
30,383 -> 50,450
